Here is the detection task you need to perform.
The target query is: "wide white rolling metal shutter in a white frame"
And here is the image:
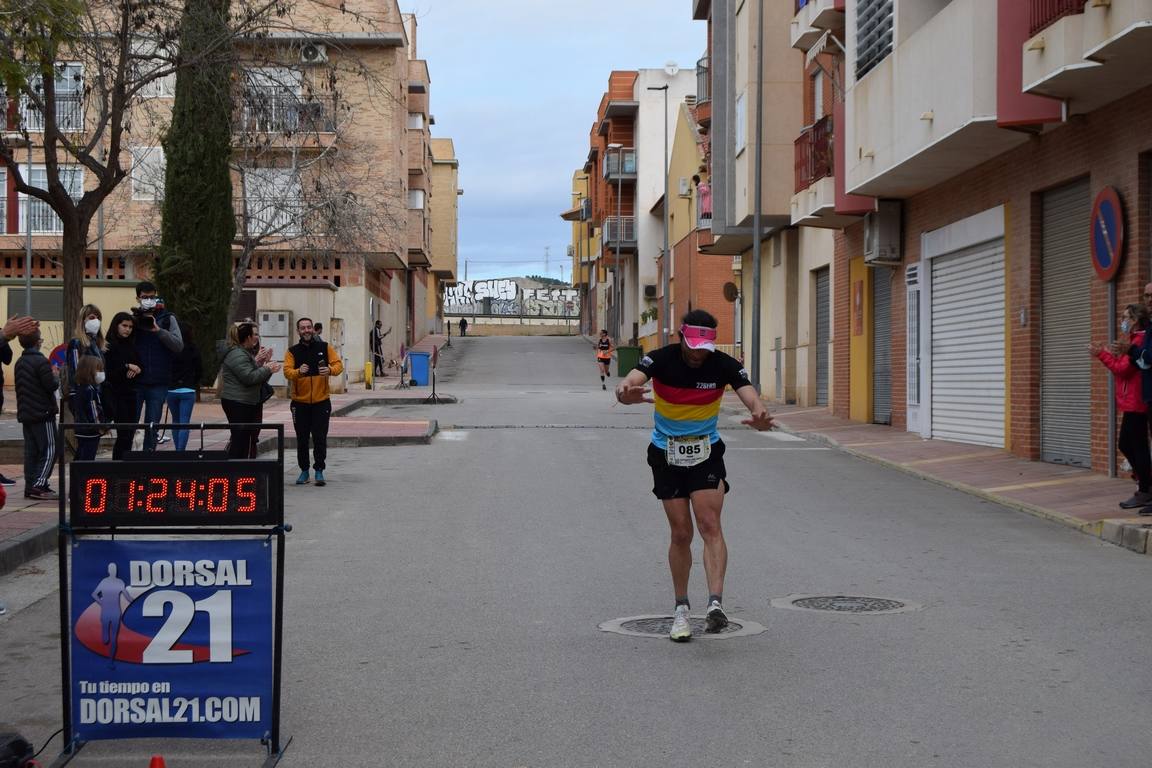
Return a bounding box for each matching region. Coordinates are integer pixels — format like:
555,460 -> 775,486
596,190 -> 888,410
931,239 -> 999,448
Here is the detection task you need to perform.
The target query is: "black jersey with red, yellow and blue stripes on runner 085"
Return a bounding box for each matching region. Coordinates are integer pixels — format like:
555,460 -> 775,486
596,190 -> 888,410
636,343 -> 752,449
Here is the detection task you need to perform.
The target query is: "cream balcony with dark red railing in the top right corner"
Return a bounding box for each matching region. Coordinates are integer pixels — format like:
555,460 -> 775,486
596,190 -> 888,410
1022,0 -> 1152,114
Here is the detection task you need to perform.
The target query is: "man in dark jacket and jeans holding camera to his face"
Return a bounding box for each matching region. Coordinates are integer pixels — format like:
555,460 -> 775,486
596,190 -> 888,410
132,280 -> 184,450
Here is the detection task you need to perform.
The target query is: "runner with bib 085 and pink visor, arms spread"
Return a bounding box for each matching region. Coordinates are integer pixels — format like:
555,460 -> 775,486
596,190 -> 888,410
616,310 -> 773,642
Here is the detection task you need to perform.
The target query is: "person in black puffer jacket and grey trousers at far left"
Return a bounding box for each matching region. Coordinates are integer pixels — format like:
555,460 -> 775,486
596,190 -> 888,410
14,330 -> 60,501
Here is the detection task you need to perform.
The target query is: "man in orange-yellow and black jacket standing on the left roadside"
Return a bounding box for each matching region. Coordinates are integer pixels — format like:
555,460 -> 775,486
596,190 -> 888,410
283,318 -> 344,486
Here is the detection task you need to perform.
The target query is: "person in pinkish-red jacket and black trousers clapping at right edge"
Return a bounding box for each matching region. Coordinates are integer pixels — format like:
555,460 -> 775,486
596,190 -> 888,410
1091,304 -> 1152,515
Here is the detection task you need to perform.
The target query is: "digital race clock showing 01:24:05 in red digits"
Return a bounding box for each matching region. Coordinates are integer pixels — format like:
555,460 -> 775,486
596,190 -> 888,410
69,459 -> 283,527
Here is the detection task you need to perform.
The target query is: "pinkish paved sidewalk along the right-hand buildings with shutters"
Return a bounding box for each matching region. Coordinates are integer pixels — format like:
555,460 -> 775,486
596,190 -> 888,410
764,395 -> 1152,555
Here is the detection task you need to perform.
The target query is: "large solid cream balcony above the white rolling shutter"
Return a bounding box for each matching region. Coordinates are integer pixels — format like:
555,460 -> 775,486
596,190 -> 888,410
836,0 -> 1028,197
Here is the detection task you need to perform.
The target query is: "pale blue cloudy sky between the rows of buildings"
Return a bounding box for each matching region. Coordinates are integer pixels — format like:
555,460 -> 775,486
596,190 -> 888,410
410,0 -> 707,280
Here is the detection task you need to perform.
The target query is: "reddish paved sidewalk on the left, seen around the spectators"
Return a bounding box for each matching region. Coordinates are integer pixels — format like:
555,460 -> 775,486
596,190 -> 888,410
0,336 -> 455,576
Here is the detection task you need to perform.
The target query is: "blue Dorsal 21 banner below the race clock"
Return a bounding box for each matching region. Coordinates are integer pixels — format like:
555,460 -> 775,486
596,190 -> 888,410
70,538 -> 275,742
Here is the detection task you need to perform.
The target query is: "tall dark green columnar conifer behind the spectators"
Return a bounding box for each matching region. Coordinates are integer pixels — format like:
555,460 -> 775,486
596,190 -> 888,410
156,0 -> 236,382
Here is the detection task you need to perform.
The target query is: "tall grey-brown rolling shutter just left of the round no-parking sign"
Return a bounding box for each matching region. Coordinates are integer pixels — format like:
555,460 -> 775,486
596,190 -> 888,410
1040,180 -> 1094,466
